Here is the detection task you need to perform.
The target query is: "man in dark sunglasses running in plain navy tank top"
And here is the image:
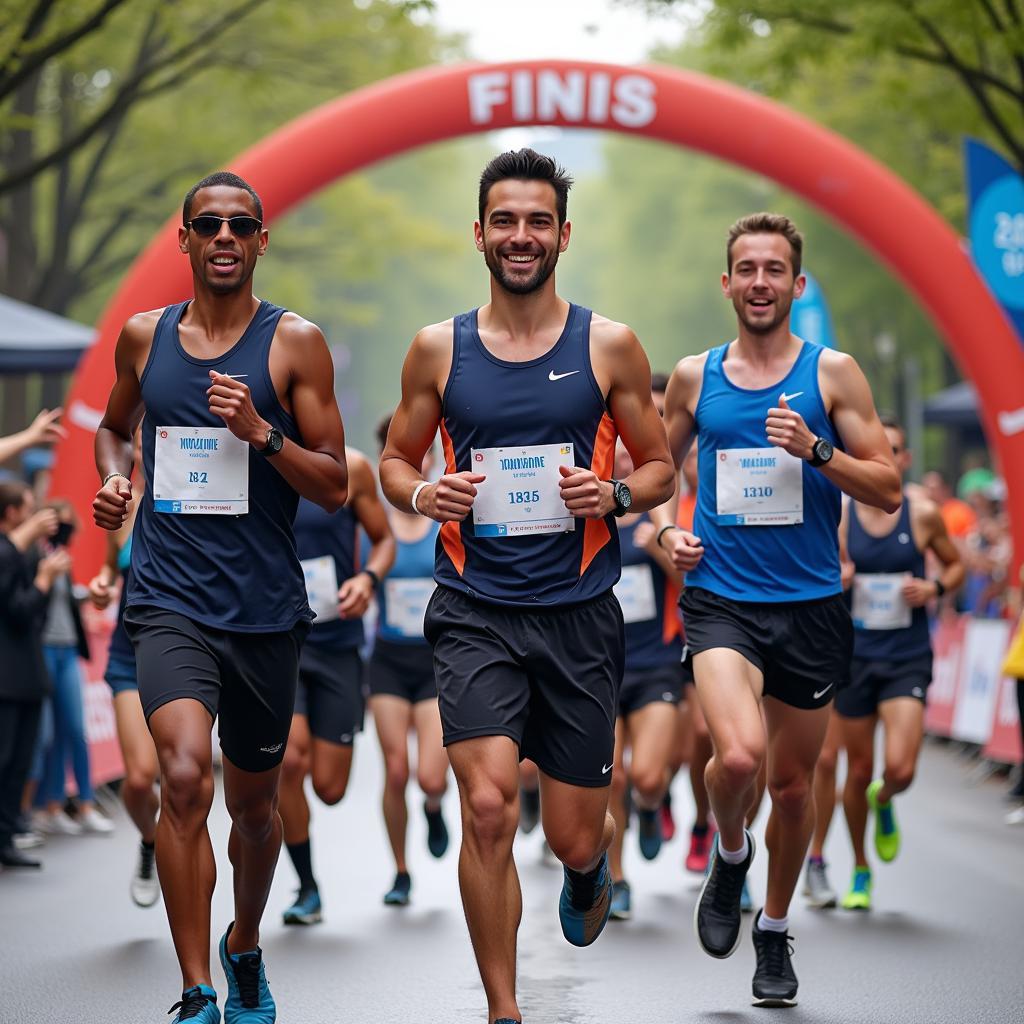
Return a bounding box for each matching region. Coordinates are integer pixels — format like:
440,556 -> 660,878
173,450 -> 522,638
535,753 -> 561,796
93,171 -> 347,1024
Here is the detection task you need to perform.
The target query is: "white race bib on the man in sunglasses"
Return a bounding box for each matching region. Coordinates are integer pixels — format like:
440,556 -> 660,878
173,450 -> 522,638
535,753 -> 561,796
153,427 -> 249,515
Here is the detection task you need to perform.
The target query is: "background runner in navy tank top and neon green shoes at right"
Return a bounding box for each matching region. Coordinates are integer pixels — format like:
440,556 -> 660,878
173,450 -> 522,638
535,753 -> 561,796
836,411 -> 964,910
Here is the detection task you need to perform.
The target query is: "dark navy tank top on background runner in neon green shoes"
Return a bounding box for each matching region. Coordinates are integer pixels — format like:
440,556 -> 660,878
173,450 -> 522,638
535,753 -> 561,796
846,494 -> 932,662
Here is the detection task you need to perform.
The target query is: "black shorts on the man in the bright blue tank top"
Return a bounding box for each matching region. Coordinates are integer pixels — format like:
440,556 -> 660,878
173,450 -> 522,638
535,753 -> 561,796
679,587 -> 853,710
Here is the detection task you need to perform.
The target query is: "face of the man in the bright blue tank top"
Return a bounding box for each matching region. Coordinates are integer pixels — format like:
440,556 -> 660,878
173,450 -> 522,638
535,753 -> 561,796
722,232 -> 805,334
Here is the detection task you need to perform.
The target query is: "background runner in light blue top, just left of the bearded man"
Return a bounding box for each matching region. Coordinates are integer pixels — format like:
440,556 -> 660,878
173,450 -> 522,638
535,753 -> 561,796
370,416 -> 449,906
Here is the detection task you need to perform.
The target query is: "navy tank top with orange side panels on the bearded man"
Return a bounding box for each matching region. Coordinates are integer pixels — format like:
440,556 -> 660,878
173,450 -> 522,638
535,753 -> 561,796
434,305 -> 620,607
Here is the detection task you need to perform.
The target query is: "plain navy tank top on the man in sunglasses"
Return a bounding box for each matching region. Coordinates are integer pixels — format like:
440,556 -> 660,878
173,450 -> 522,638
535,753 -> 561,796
128,302 -> 312,633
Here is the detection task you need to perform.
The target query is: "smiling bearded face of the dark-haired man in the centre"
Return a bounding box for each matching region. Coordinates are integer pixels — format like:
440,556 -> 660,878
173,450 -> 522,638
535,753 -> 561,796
473,178 -> 569,295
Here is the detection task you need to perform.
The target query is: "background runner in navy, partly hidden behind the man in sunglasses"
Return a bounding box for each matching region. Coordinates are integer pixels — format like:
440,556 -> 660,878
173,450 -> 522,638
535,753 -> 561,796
280,449 -> 394,925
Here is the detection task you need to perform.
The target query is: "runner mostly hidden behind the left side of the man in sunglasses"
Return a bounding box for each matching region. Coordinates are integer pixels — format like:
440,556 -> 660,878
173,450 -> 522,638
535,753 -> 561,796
89,430 -> 160,906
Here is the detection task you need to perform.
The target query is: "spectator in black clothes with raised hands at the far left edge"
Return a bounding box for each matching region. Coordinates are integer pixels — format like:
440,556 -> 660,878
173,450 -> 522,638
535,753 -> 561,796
0,481 -> 71,867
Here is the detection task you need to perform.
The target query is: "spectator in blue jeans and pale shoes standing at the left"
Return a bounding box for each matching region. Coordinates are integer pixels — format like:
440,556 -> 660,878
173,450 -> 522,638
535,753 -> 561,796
37,501 -> 114,835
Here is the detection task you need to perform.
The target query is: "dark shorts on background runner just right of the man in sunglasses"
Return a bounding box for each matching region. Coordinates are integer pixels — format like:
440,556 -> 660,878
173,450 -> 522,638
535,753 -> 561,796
295,643 -> 366,746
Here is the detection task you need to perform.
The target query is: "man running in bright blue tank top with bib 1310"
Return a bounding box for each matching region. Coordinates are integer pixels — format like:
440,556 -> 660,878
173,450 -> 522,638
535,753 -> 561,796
658,214 -> 900,1006
